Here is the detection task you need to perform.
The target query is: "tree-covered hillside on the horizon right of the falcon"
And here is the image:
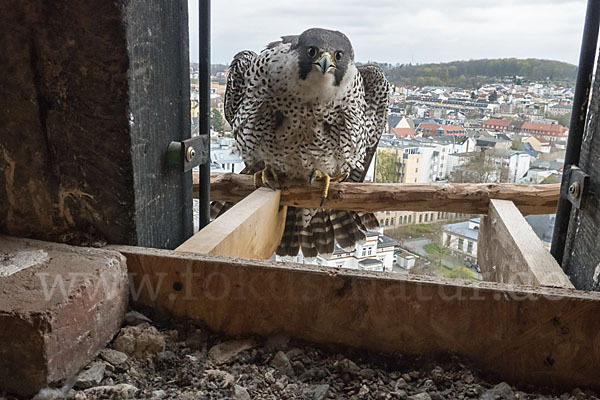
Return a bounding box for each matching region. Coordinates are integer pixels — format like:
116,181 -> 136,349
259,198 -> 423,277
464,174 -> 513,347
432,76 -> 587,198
380,58 -> 577,89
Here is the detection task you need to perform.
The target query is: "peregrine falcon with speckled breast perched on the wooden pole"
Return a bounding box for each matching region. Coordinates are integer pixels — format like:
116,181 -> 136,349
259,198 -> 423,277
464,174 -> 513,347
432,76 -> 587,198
212,28 -> 389,257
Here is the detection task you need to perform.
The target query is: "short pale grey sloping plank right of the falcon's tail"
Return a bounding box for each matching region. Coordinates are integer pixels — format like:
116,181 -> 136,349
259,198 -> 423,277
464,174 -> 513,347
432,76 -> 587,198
477,200 -> 573,288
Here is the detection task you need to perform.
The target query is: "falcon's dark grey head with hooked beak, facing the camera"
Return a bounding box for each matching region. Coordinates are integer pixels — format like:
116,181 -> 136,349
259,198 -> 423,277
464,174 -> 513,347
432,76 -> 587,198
294,28 -> 354,86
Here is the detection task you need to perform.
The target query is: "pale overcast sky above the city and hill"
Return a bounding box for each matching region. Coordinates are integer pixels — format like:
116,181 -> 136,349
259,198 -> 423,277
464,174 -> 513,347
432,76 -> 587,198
188,0 -> 586,64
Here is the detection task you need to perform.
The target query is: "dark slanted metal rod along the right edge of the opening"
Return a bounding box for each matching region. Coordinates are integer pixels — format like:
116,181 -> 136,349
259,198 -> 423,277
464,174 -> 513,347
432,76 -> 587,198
550,0 -> 600,268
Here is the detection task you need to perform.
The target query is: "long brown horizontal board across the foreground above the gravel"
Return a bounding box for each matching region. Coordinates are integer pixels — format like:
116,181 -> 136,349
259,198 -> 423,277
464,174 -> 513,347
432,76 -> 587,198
113,247 -> 600,389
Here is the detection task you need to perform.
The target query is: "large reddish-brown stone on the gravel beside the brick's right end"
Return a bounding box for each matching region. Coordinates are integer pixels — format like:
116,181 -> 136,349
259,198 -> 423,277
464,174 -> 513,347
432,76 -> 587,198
112,325 -> 166,358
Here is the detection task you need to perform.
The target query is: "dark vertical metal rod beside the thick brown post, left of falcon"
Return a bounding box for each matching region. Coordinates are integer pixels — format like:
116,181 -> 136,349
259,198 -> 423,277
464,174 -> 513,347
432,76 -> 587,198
198,0 -> 210,229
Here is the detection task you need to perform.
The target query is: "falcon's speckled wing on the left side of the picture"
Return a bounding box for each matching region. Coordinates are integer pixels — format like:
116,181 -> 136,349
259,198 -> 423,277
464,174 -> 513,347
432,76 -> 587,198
225,50 -> 256,127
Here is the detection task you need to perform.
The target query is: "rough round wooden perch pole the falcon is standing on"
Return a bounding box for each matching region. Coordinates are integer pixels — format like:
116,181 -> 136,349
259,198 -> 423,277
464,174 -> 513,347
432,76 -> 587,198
199,174 -> 560,215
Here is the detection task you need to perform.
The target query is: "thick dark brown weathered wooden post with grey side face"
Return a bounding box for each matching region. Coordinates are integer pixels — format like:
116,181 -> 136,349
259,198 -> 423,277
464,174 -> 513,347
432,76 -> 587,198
0,0 -> 193,249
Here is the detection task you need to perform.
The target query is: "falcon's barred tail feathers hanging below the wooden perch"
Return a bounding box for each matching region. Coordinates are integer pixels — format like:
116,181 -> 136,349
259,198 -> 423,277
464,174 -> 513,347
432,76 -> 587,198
277,207 -> 379,257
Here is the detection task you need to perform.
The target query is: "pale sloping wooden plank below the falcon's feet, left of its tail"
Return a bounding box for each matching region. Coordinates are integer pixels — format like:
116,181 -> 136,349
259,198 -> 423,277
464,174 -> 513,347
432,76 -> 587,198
177,188 -> 287,259
